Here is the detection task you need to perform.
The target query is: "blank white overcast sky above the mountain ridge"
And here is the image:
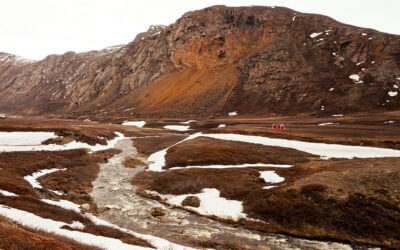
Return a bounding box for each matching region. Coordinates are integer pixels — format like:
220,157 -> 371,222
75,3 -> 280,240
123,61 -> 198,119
0,0 -> 400,59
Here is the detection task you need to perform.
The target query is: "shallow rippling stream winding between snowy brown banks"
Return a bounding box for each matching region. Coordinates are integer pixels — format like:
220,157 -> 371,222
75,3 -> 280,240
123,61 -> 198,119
91,138 -> 351,249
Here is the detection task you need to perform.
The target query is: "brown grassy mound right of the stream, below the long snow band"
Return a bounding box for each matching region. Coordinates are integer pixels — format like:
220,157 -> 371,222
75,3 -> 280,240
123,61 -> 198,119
132,158 -> 400,248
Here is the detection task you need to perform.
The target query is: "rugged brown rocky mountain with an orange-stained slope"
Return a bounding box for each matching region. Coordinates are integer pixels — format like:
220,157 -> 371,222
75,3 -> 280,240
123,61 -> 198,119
0,6 -> 400,116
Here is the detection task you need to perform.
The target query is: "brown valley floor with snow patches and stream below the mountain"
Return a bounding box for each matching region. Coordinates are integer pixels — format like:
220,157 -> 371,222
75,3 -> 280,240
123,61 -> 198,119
0,112 -> 400,249
